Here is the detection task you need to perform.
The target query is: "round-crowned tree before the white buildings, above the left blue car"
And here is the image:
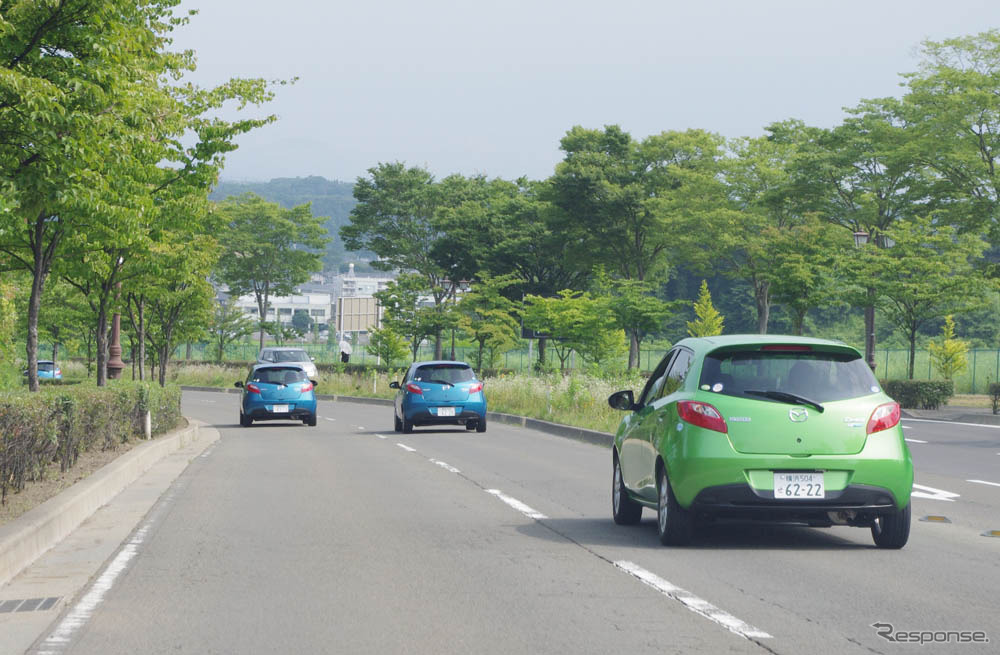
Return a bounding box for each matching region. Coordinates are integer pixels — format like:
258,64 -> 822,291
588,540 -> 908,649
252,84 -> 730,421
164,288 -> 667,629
216,193 -> 328,348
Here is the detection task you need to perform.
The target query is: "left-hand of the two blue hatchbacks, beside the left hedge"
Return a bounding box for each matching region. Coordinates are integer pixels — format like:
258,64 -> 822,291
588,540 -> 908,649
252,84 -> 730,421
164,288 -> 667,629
236,364 -> 316,428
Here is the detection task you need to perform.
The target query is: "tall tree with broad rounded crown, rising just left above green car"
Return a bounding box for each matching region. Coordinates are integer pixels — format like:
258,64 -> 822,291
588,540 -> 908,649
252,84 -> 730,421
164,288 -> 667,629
551,125 -> 725,361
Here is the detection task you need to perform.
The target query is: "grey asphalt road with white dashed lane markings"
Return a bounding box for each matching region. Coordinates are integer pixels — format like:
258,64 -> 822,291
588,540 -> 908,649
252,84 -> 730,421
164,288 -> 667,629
27,392 -> 1000,655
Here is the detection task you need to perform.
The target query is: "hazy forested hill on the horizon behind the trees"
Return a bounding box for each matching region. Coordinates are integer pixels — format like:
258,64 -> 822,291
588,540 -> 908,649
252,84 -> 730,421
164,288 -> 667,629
209,175 -> 357,271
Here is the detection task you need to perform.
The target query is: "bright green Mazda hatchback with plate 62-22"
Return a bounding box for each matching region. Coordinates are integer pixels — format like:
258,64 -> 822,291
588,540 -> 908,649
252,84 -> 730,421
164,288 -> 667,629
608,335 -> 913,548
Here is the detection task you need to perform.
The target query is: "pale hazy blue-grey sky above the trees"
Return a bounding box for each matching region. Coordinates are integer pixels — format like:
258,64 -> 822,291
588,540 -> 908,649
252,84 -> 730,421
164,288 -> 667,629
175,0 -> 1000,181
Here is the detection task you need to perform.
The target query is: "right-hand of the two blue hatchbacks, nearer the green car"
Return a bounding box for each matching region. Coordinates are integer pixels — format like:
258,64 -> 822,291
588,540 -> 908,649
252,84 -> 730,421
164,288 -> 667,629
389,361 -> 486,433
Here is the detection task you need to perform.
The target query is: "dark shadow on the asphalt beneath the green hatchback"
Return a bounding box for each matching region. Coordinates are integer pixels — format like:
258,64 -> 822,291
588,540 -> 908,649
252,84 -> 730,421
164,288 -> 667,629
517,517 -> 874,550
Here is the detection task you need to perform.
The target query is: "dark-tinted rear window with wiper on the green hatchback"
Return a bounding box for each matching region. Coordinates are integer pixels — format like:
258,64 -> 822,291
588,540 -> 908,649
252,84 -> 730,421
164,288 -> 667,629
698,350 -> 881,403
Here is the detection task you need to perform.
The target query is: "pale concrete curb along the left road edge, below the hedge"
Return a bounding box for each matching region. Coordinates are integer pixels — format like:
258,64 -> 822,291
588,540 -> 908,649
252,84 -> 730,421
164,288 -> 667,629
0,420 -> 218,586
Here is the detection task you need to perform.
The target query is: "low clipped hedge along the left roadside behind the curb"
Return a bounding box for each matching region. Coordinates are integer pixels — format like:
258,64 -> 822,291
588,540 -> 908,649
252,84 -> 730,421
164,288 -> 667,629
0,382 -> 181,502
